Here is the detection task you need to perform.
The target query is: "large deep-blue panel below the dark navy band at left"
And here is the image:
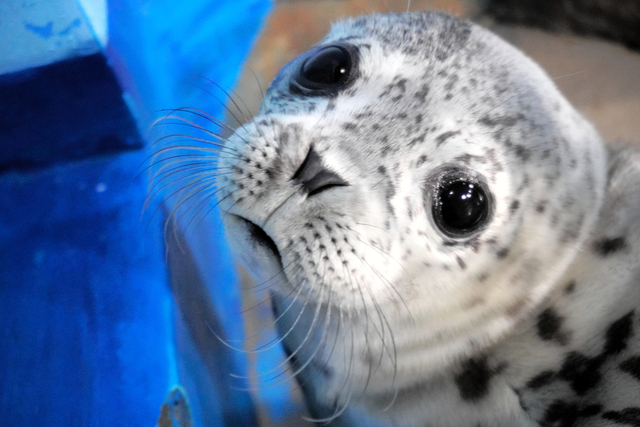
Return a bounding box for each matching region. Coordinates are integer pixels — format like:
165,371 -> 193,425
0,152 -> 173,427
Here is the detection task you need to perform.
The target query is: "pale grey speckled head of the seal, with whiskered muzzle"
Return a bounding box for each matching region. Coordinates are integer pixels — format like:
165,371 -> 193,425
217,13 -> 605,402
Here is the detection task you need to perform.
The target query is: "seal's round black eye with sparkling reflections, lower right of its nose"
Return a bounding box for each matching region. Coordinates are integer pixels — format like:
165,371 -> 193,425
433,179 -> 489,236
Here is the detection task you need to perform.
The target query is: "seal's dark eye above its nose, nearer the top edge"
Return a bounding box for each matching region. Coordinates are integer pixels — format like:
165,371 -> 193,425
291,44 -> 356,96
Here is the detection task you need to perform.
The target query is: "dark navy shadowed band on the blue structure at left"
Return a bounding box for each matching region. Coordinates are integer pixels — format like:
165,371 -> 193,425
0,53 -> 143,172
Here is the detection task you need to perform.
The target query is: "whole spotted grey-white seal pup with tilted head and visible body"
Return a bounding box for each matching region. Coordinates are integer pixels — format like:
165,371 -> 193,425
217,13 -> 640,427
